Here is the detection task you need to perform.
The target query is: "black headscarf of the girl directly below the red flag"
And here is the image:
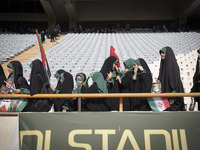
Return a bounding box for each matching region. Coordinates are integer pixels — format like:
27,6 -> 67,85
100,56 -> 118,79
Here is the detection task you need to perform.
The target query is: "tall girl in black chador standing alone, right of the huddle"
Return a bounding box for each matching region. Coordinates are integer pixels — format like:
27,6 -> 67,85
158,47 -> 185,111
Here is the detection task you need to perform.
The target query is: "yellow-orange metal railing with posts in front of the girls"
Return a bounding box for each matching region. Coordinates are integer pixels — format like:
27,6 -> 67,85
0,93 -> 200,114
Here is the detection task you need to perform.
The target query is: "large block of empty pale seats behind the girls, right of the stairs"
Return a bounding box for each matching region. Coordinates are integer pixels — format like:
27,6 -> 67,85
20,31 -> 200,92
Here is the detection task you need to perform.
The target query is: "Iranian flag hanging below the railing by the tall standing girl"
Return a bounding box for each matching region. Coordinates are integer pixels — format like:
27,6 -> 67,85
147,97 -> 170,112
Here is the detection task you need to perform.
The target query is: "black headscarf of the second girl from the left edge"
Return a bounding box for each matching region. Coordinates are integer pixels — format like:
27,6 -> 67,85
7,61 -> 23,89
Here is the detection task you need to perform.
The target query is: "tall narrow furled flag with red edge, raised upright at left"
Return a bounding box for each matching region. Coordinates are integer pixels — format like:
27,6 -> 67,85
35,29 -> 51,78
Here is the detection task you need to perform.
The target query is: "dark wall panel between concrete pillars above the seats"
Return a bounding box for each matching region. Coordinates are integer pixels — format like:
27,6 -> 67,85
78,0 -> 175,21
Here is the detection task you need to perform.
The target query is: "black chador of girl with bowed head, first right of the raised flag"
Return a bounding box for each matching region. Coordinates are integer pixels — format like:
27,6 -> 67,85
54,70 -> 74,111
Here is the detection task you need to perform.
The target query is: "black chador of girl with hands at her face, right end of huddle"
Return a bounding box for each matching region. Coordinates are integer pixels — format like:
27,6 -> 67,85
131,58 -> 152,111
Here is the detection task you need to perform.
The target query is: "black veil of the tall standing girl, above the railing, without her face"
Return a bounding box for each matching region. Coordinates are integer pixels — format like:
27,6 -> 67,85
158,47 -> 184,93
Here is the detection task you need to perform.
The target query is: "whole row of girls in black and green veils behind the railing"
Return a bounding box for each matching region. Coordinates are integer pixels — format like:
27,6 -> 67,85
0,47 -> 200,112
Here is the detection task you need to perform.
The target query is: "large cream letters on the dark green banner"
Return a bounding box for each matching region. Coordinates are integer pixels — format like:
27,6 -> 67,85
20,129 -> 188,150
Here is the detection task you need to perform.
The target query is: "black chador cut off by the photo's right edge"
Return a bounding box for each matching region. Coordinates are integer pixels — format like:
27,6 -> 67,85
191,49 -> 200,110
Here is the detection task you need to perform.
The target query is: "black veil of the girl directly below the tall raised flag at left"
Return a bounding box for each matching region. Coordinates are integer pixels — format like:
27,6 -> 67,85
30,59 -> 49,95
